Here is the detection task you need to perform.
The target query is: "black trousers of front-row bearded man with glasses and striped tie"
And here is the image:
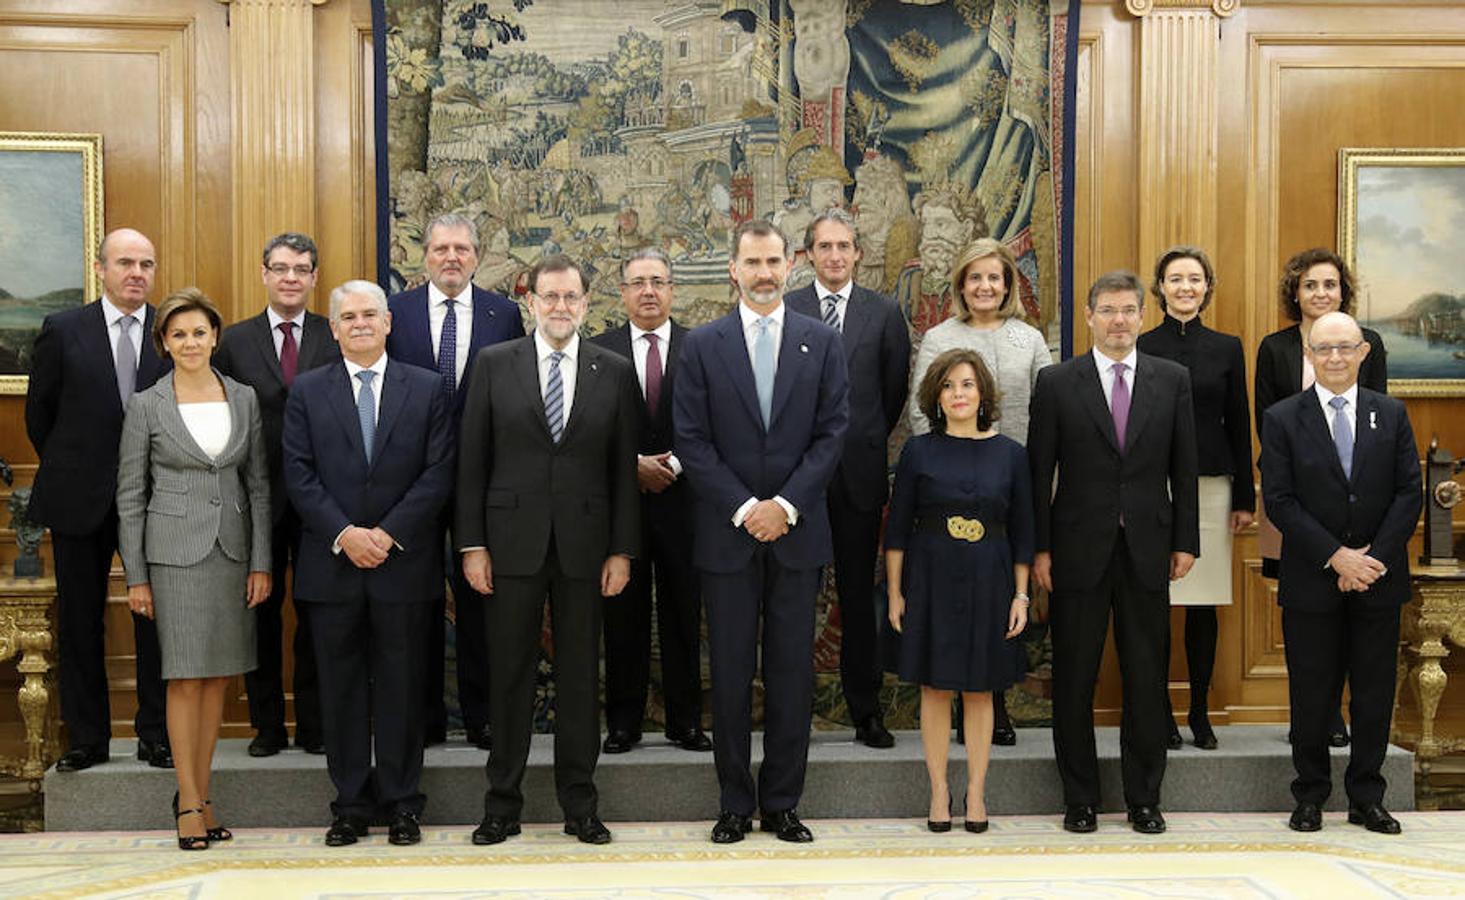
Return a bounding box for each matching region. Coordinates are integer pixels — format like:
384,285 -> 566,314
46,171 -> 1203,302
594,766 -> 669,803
483,538 -> 605,821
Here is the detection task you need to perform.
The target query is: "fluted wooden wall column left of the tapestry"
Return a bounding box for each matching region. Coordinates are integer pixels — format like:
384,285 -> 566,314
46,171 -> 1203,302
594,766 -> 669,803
220,0 -> 328,320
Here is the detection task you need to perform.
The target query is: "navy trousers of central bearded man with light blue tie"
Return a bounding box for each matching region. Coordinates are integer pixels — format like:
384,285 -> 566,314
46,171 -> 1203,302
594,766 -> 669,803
702,545 -> 819,815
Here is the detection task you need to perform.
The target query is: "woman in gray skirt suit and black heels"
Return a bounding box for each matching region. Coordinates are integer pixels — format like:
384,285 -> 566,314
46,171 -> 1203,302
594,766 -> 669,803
117,287 -> 270,850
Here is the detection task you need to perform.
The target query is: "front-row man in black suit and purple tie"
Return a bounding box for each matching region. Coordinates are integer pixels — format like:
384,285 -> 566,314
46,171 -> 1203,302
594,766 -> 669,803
1027,273 -> 1200,834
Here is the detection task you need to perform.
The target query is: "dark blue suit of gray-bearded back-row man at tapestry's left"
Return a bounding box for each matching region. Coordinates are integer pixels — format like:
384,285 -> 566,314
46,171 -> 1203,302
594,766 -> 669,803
387,284 -> 524,740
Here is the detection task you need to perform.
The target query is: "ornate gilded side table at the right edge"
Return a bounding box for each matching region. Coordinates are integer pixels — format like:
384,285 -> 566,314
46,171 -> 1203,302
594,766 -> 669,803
1396,566 -> 1465,775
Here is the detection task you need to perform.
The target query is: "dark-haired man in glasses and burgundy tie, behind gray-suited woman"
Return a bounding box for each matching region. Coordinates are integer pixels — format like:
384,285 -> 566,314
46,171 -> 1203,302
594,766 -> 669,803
214,232 -> 341,756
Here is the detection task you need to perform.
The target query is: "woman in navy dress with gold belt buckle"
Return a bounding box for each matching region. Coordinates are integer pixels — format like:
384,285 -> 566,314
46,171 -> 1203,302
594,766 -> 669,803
885,349 -> 1033,833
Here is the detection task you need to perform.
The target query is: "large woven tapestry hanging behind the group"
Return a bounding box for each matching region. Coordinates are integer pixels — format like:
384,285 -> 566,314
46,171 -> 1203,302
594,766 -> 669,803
374,0 -> 1078,730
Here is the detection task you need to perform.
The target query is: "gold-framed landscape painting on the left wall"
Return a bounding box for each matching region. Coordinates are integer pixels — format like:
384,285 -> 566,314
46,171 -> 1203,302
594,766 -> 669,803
0,132 -> 103,394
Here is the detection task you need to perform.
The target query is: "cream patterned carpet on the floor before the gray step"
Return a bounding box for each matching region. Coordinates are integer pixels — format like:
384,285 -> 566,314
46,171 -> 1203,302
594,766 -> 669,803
0,812 -> 1465,900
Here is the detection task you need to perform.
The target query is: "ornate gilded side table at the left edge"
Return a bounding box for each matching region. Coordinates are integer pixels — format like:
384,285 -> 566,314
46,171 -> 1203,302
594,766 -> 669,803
0,575 -> 57,790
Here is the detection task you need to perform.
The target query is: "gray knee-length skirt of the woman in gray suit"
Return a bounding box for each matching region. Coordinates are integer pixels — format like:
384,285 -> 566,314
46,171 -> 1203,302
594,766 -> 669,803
148,544 -> 258,680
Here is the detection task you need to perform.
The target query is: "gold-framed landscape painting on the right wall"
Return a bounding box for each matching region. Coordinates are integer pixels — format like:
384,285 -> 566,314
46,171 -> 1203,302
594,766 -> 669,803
1338,147 -> 1465,397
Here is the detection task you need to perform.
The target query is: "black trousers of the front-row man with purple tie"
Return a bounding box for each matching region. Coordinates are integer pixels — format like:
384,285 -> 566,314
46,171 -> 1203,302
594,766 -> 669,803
1050,529 -> 1171,806
